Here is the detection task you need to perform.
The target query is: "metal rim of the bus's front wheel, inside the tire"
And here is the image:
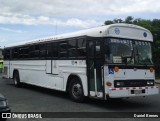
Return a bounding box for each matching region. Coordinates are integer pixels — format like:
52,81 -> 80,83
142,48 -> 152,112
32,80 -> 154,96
72,83 -> 82,98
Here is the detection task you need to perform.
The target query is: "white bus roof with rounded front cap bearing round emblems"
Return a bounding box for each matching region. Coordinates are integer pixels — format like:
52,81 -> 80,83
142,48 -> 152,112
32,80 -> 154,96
6,23 -> 153,47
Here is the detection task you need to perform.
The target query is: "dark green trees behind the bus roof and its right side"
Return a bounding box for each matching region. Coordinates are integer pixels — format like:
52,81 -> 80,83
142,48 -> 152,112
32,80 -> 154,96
104,16 -> 160,77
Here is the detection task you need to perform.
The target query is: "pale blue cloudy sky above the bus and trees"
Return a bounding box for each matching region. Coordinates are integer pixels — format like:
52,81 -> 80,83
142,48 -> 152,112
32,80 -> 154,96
0,0 -> 160,48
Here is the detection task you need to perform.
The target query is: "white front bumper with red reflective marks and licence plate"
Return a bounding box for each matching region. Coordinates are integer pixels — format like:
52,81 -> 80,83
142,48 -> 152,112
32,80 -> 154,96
109,86 -> 159,98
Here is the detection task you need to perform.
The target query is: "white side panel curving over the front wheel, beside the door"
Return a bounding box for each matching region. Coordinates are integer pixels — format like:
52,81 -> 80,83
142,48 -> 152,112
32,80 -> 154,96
56,60 -> 88,96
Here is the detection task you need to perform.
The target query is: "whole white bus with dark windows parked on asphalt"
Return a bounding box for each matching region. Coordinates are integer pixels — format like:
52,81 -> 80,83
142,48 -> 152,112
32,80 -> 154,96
4,24 -> 159,102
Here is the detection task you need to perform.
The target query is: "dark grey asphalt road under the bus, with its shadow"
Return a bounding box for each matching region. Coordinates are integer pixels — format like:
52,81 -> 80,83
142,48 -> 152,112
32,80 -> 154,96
0,79 -> 160,121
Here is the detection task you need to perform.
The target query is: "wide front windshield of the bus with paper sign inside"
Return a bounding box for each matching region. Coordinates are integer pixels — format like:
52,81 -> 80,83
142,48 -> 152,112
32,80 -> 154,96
104,38 -> 153,65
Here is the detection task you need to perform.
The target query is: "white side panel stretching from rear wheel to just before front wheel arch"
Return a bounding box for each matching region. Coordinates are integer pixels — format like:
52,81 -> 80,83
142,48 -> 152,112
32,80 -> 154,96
13,60 -> 63,90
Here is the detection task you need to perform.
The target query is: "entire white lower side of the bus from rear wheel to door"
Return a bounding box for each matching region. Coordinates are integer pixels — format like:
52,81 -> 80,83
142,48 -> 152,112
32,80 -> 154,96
8,60 -> 88,96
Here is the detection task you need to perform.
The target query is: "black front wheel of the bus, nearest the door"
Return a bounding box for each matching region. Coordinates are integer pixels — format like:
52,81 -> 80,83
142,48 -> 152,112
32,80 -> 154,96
69,78 -> 84,102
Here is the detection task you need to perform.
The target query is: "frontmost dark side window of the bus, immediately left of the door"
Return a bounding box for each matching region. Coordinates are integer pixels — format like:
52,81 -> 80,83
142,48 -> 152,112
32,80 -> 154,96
77,39 -> 86,58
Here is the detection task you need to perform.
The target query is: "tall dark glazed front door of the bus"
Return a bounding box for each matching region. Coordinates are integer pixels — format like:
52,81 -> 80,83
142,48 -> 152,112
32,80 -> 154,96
87,39 -> 104,98
